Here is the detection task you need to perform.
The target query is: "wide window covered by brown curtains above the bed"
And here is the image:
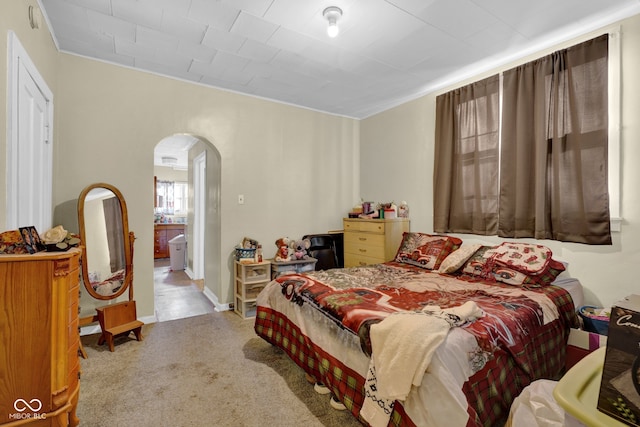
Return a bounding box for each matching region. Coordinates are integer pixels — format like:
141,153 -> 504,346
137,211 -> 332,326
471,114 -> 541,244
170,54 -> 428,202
434,35 -> 611,244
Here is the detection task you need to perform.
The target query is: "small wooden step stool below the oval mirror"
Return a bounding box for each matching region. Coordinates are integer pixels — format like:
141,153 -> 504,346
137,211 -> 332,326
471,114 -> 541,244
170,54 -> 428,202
96,301 -> 144,351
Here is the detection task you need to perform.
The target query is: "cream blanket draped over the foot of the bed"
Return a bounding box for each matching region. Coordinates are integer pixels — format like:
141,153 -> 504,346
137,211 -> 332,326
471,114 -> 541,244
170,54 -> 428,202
360,301 -> 482,427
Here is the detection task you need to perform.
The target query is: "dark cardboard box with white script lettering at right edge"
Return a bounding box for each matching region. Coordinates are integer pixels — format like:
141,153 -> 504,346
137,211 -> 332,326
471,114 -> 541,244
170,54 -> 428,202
598,295 -> 640,426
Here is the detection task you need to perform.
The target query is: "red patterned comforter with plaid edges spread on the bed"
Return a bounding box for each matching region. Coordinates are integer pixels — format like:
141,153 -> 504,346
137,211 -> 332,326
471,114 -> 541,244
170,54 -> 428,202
255,262 -> 575,426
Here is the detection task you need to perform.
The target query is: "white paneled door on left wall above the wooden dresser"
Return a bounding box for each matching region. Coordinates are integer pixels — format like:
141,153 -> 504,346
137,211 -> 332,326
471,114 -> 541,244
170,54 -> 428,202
7,34 -> 53,233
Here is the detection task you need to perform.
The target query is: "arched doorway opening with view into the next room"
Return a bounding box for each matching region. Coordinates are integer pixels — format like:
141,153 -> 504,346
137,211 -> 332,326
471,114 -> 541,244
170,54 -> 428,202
154,134 -> 221,321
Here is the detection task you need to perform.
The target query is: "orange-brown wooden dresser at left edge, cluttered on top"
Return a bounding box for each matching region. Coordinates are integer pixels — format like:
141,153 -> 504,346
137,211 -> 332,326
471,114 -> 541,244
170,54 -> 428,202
0,248 -> 81,427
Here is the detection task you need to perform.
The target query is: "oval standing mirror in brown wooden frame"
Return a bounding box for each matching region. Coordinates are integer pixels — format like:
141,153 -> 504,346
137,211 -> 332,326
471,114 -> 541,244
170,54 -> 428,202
78,183 -> 133,300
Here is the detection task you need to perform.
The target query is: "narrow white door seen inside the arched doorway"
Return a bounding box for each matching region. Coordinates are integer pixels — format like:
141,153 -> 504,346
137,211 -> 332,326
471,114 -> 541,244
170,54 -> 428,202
193,152 -> 207,280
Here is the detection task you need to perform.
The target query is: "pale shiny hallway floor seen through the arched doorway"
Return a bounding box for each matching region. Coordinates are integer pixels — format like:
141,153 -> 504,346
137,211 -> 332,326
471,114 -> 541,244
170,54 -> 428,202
153,259 -> 215,322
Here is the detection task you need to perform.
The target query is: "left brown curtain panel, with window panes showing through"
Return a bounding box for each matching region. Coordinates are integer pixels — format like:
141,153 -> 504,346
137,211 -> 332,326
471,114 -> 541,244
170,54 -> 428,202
433,75 -> 500,235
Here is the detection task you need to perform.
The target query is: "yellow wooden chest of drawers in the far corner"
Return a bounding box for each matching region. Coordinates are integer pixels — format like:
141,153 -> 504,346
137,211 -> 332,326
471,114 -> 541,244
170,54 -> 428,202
342,218 -> 409,267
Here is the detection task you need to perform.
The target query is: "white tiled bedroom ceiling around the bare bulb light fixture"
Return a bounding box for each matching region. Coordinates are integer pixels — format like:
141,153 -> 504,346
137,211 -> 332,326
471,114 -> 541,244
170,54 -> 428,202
38,0 -> 640,166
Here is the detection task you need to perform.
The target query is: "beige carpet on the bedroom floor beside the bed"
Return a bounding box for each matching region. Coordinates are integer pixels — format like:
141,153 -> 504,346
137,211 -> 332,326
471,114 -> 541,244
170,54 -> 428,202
78,312 -> 361,427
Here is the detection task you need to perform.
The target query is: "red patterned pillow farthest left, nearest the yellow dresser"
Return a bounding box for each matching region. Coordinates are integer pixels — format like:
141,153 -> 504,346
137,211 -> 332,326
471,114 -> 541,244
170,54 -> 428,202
395,232 -> 462,270
